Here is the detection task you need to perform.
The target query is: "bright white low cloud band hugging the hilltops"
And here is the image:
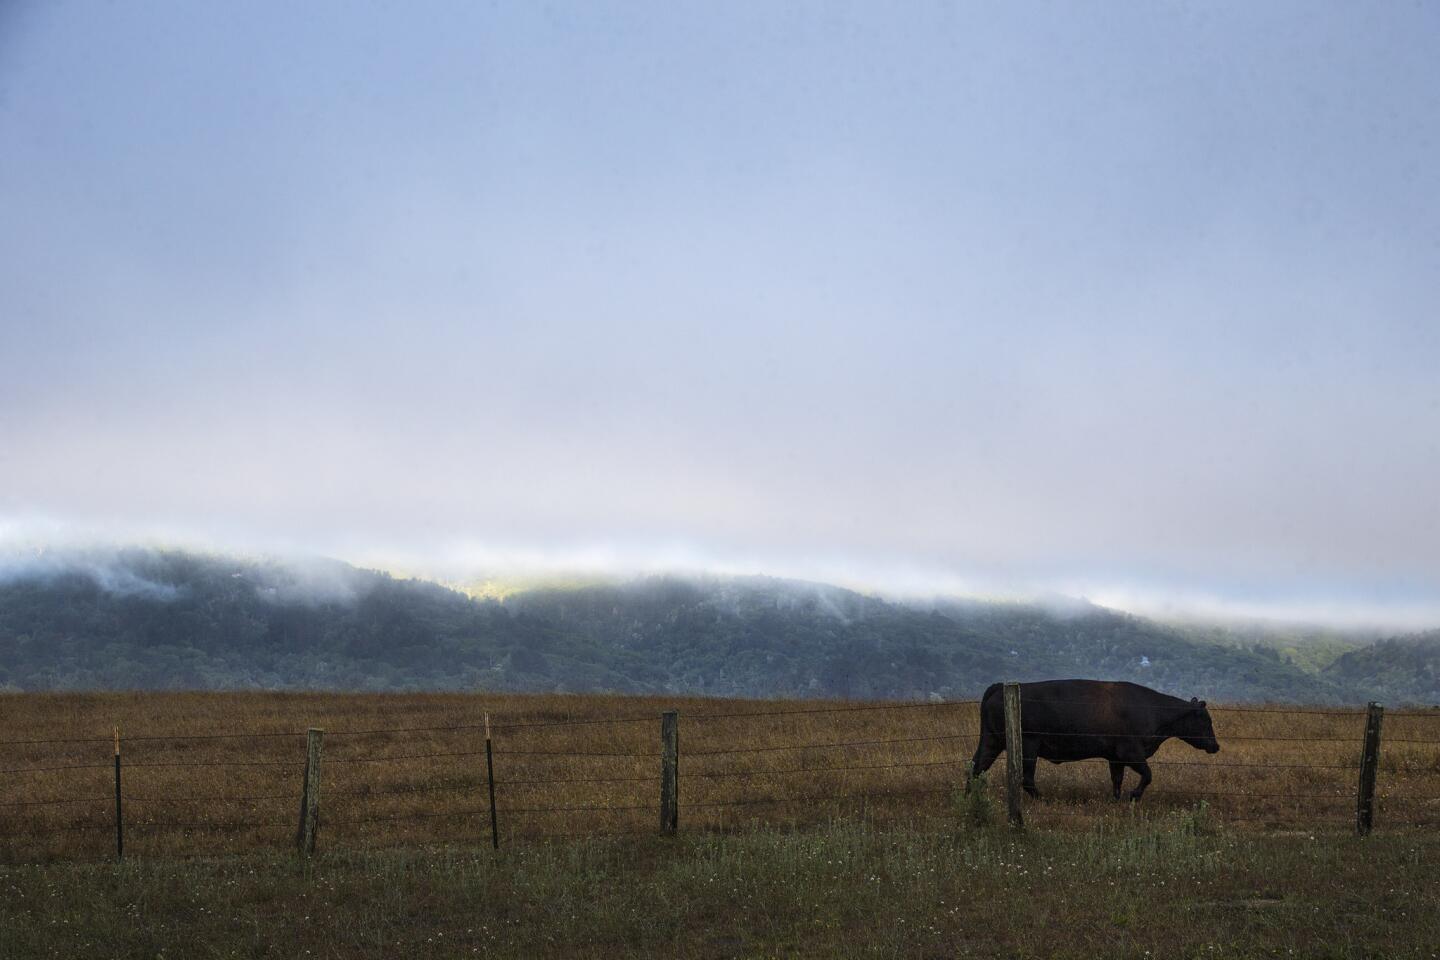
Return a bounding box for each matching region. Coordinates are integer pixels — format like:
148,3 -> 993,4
0,518 -> 1440,633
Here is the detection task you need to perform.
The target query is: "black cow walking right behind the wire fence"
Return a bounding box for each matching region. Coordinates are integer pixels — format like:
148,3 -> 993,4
973,679 -> 1220,800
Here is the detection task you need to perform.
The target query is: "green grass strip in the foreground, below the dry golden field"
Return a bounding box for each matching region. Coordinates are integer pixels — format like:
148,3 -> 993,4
0,810 -> 1440,960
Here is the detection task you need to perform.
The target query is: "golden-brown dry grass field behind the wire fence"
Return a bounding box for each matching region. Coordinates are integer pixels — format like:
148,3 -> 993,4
0,694 -> 1440,862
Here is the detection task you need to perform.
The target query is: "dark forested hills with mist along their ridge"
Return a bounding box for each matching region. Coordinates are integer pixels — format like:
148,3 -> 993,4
0,548 -> 1440,702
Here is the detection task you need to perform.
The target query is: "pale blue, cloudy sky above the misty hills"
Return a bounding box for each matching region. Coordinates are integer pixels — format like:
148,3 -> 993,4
0,0 -> 1440,628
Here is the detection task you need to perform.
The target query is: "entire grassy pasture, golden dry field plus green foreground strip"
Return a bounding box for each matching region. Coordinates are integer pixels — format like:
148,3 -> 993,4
0,694 -> 1440,957
